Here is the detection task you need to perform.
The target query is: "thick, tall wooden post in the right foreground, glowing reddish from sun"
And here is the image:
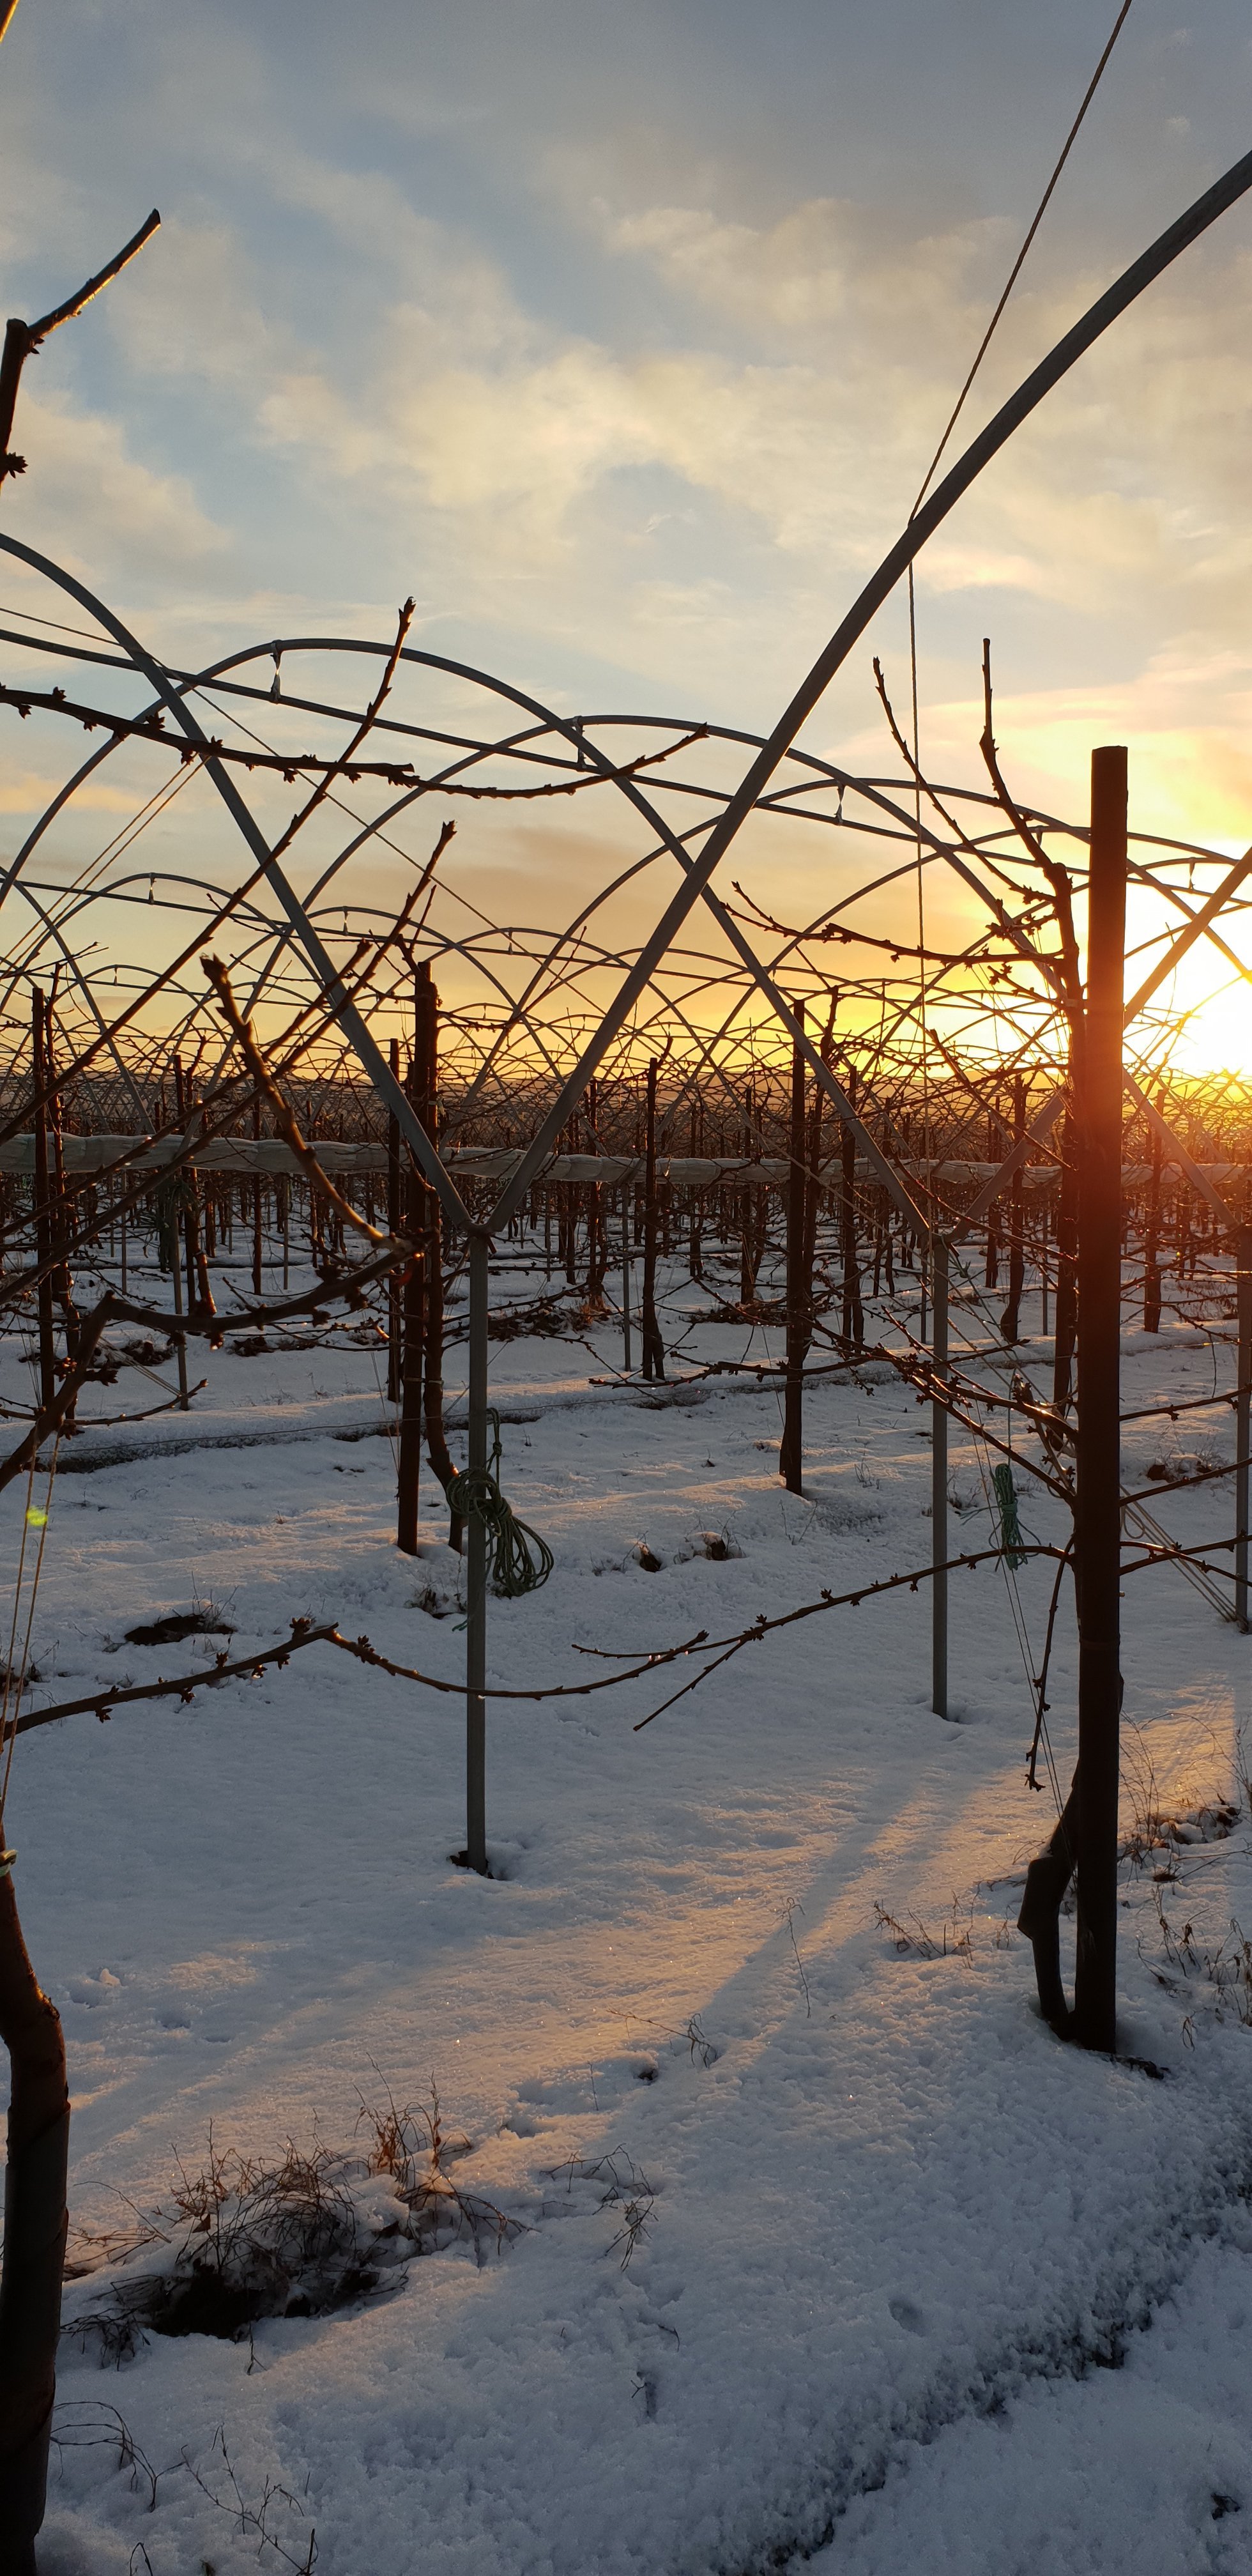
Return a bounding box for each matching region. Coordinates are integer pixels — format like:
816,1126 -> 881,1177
1074,744 -> 1126,2053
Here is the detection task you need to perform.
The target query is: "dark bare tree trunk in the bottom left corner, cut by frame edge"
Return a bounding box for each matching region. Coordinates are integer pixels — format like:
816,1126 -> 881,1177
0,1837 -> 70,2576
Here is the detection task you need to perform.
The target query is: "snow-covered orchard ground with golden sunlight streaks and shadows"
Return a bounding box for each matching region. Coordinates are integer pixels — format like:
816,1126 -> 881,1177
3,1236 -> 1252,2576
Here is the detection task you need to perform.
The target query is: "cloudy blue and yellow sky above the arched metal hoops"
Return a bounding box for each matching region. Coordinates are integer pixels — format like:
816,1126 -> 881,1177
0,0 -> 1252,1061
